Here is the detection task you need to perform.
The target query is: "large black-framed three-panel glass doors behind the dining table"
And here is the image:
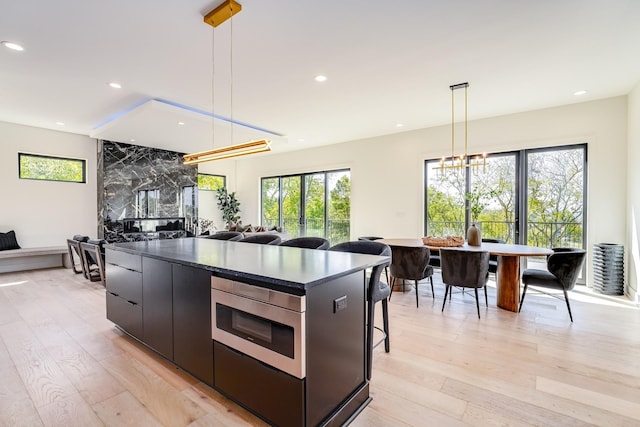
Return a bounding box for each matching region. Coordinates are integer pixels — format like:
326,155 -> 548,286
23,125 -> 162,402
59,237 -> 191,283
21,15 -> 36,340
425,144 -> 587,248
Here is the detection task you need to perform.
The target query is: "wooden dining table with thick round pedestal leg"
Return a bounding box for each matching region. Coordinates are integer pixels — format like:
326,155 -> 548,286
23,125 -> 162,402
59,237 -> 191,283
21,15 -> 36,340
376,238 -> 553,312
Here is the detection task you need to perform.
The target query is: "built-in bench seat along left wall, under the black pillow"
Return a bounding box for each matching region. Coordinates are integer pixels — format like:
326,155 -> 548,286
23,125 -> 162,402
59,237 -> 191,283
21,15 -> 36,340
0,246 -> 71,273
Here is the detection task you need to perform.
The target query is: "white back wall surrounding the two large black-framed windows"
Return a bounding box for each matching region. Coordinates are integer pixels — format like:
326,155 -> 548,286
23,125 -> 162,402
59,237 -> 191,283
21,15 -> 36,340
234,96 -> 628,290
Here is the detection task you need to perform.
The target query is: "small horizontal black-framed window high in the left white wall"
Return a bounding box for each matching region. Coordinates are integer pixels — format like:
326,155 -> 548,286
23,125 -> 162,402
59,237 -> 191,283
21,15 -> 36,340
18,153 -> 87,183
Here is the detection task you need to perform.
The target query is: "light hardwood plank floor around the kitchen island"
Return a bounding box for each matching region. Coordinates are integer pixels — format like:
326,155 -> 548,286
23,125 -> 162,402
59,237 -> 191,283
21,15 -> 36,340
0,268 -> 640,427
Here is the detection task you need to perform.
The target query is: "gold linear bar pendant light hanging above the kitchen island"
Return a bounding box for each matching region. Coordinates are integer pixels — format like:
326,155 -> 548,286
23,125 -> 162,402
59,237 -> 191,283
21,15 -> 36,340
183,0 -> 271,165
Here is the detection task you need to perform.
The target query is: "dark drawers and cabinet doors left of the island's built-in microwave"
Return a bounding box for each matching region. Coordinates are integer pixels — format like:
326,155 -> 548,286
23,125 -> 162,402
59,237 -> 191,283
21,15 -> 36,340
106,249 -> 213,386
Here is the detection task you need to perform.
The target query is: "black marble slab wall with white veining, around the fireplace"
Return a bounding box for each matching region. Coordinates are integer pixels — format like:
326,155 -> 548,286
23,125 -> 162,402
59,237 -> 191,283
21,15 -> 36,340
98,141 -> 198,241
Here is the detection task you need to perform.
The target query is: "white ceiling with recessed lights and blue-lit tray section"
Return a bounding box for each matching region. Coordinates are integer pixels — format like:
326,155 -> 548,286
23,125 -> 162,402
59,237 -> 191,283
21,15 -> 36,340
0,0 -> 640,152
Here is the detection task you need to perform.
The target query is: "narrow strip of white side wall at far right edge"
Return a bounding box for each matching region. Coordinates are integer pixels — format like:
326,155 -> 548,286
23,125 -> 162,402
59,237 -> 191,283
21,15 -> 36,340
625,83 -> 640,302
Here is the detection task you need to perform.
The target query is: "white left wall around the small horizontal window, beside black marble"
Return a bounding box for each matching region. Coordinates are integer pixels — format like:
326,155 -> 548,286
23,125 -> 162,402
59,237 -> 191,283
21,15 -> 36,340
0,122 -> 97,248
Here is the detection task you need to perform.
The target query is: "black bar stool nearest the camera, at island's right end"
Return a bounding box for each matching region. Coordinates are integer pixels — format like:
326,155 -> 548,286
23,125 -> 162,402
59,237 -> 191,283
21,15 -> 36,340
328,240 -> 391,380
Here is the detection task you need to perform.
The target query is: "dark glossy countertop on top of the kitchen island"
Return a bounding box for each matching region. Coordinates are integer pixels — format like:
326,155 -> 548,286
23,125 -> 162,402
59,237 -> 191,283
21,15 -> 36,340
107,238 -> 390,292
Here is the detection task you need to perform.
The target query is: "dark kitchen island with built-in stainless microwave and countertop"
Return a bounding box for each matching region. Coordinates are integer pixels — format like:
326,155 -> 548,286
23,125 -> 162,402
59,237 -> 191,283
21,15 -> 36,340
106,238 -> 389,426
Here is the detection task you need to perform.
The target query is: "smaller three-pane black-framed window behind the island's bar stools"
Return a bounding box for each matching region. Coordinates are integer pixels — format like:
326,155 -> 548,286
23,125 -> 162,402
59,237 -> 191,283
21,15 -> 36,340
260,170 -> 351,244
